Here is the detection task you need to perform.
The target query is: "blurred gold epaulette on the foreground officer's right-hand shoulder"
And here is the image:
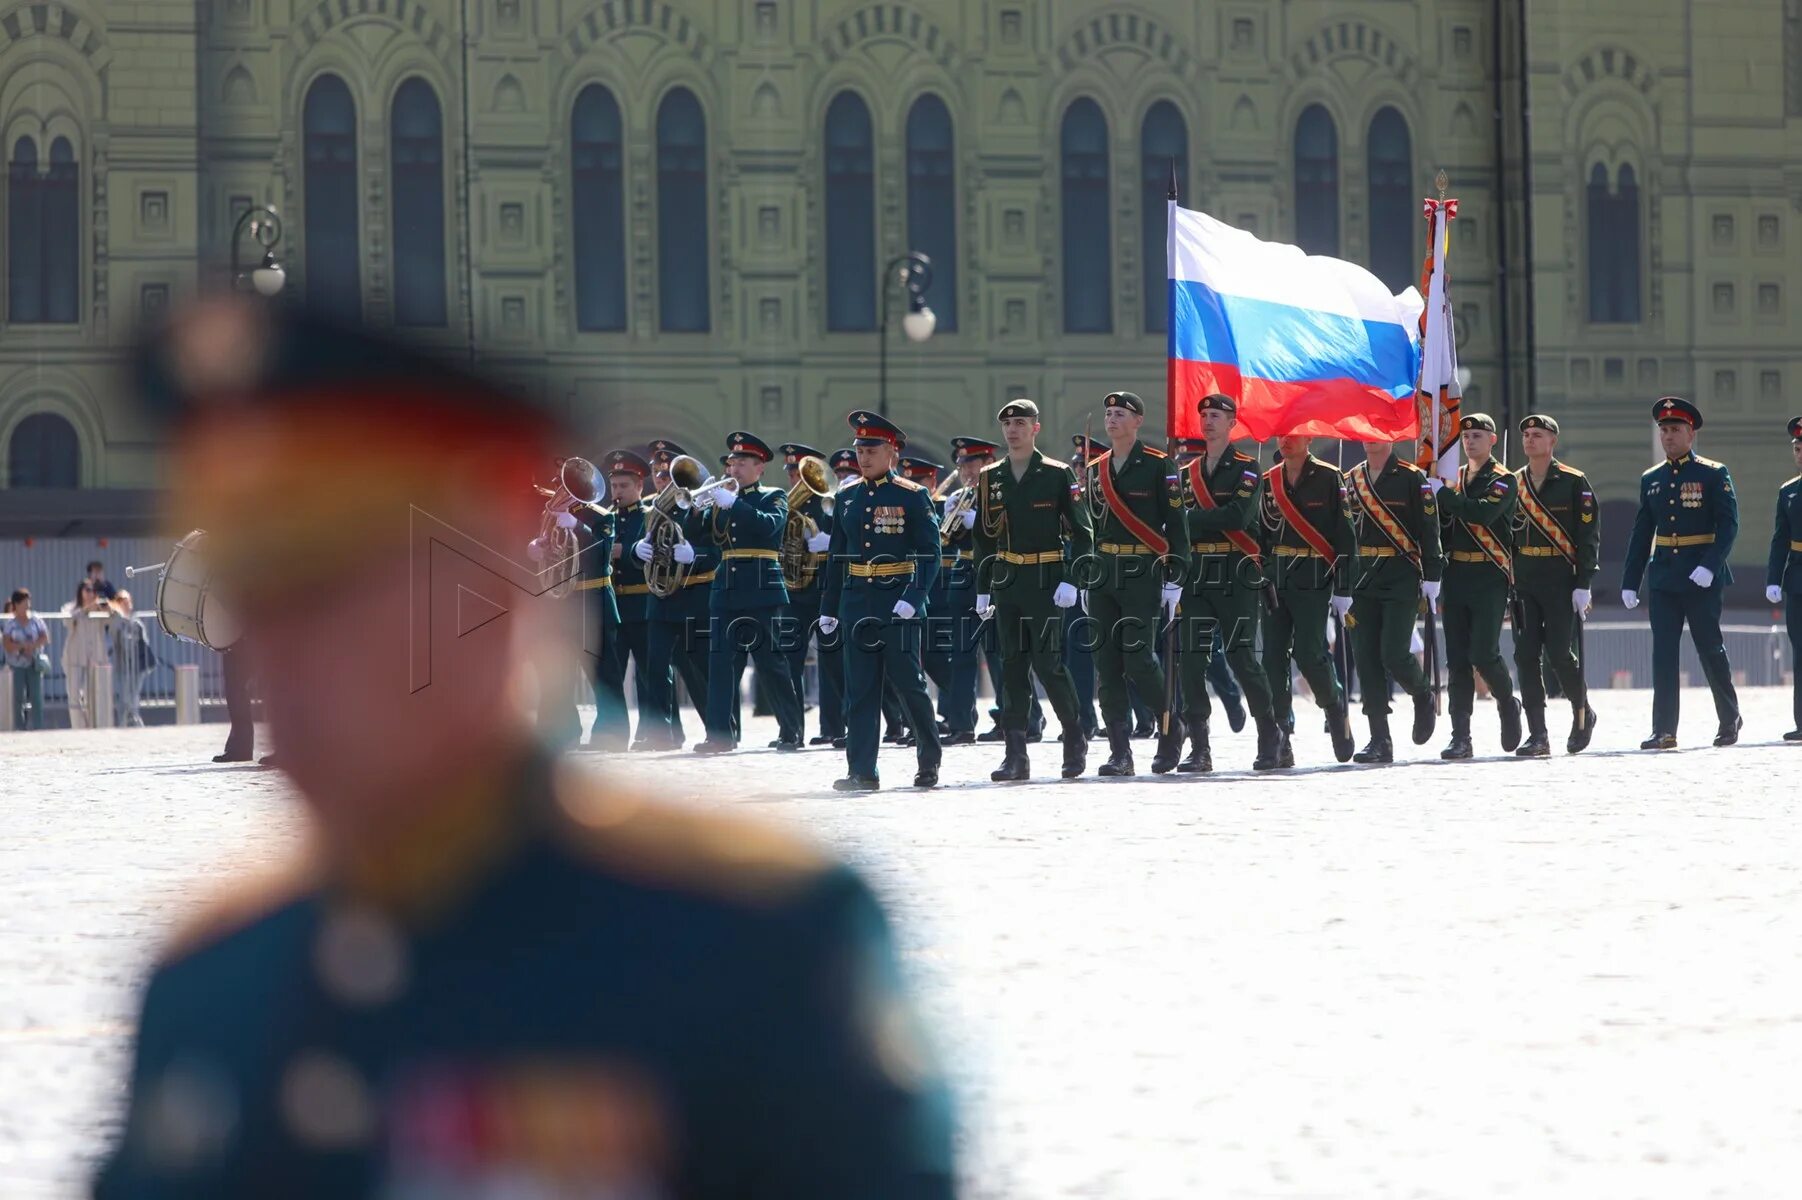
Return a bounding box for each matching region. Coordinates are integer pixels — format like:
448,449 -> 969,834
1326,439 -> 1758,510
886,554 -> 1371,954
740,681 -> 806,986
555,768 -> 836,905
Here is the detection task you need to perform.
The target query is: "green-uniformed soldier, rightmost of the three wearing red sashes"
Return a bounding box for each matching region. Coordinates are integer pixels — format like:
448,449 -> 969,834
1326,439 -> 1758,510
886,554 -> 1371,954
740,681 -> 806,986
1261,434 -> 1357,762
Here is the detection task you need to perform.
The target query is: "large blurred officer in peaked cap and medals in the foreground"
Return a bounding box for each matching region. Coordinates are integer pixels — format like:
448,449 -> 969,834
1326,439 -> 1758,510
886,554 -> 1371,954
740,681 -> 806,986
96,299 -> 953,1200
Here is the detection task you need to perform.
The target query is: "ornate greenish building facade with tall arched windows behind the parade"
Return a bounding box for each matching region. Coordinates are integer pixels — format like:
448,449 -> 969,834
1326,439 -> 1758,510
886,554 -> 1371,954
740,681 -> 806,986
0,0 -> 1802,551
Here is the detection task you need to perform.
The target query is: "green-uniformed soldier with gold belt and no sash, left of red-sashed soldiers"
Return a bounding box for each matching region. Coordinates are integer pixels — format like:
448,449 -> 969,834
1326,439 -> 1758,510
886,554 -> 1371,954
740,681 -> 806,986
975,398 -> 1094,782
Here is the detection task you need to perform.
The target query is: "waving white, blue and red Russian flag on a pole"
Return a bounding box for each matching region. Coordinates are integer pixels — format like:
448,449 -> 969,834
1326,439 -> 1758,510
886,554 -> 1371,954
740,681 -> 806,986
1166,200 -> 1422,441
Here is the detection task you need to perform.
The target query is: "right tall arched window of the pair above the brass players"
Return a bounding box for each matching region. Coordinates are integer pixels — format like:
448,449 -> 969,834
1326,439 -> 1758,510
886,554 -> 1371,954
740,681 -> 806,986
658,88 -> 712,333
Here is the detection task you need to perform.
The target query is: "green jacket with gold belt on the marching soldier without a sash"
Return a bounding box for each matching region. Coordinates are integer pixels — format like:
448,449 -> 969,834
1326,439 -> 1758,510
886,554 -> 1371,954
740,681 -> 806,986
975,450 -> 1094,600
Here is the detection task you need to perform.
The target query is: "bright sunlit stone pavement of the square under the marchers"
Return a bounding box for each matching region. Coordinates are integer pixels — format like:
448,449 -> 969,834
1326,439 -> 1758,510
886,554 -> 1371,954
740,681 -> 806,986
0,690 -> 1802,1200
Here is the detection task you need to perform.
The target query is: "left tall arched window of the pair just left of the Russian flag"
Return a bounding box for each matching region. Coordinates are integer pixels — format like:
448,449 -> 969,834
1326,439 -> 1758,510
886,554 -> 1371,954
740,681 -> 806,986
1061,95 -> 1114,333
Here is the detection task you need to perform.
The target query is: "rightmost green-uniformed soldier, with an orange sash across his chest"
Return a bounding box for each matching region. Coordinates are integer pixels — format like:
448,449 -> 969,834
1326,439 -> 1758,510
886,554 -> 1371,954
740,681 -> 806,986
1514,413 -> 1602,759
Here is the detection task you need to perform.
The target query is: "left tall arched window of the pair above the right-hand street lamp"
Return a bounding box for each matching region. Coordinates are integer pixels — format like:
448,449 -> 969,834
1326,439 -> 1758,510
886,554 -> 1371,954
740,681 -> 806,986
825,92 -> 876,332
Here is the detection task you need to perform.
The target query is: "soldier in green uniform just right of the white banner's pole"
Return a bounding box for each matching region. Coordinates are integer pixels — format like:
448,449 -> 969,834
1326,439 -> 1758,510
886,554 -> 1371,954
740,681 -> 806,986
1433,413 -> 1521,759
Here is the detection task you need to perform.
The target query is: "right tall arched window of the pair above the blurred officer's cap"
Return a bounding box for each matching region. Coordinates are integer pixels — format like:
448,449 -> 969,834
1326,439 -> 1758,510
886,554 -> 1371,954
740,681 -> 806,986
389,77 -> 445,326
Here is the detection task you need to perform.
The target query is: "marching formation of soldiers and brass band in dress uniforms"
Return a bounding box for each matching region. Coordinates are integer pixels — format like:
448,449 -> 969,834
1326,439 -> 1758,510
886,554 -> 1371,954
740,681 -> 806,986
571,391 -> 1802,791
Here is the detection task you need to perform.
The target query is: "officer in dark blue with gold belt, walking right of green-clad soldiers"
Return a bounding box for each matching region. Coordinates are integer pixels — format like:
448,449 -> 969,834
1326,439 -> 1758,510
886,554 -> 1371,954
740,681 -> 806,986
1620,396 -> 1741,750
